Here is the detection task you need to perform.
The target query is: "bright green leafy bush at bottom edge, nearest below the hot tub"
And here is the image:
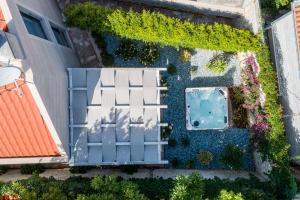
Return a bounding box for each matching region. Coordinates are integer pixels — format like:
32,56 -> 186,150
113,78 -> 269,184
171,173 -> 204,200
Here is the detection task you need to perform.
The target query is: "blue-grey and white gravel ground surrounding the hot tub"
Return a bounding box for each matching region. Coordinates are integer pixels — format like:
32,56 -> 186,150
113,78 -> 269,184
105,35 -> 254,170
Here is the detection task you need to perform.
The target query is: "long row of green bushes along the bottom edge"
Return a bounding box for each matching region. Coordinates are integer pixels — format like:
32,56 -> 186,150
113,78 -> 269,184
0,174 -> 278,200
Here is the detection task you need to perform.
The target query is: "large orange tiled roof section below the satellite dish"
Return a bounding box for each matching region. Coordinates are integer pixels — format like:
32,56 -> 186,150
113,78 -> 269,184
0,81 -> 60,158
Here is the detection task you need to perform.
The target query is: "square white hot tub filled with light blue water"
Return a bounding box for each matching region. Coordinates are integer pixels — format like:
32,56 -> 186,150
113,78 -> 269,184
185,87 -> 228,130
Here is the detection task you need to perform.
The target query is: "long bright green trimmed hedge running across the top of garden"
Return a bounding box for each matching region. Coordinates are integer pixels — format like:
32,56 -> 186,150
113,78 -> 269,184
64,3 -> 261,52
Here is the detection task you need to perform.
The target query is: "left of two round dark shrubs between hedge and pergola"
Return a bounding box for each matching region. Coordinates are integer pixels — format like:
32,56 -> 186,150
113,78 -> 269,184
116,40 -> 138,61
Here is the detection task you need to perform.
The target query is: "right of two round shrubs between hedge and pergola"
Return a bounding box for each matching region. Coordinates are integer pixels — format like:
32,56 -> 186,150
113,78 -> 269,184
139,44 -> 159,65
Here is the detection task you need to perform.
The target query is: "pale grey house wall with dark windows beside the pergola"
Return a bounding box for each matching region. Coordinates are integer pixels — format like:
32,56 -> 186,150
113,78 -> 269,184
0,0 -> 80,162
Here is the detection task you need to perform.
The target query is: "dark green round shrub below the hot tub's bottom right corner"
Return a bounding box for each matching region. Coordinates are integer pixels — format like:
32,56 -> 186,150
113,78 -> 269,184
220,144 -> 244,169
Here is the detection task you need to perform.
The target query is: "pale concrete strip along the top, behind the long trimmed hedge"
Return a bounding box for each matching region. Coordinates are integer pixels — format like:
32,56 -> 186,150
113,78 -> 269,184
121,0 -> 261,33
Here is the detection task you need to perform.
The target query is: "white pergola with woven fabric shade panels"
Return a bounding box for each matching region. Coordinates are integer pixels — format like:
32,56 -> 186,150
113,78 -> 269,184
68,68 -> 168,165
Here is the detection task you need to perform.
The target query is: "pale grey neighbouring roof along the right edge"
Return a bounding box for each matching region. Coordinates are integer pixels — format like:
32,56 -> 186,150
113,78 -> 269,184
270,11 -> 300,159
